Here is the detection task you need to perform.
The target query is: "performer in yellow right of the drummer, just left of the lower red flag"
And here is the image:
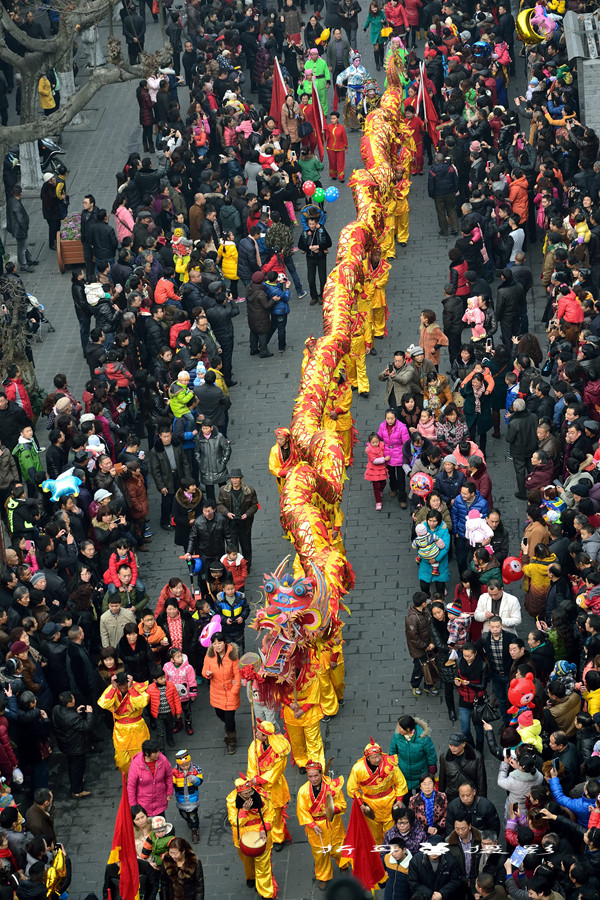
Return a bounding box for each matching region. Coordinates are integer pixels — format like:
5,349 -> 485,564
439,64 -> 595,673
296,759 -> 349,891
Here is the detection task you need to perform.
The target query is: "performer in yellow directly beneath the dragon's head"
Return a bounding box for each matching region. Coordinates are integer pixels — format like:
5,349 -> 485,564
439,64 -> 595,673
282,667 -> 325,772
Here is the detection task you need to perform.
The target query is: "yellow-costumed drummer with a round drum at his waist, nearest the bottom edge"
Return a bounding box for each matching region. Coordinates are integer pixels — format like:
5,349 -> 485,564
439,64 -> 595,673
227,773 -> 277,897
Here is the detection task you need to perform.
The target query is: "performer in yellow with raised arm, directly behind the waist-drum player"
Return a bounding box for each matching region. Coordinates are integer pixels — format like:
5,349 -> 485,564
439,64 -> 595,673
248,719 -> 292,851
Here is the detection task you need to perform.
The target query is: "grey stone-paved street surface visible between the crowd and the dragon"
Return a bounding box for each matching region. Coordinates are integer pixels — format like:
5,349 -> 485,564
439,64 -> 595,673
7,15 -> 543,900
